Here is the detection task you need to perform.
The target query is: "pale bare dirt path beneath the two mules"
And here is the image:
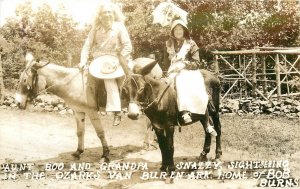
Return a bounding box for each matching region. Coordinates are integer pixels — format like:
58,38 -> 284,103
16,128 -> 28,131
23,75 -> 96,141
0,110 -> 298,189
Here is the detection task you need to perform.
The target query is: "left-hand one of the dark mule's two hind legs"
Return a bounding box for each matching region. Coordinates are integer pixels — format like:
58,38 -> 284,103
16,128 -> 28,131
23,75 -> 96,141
199,113 -> 211,161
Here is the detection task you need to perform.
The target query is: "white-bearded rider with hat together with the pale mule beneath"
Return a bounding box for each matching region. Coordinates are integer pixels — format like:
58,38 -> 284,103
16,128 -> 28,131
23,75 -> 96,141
17,2 -> 132,161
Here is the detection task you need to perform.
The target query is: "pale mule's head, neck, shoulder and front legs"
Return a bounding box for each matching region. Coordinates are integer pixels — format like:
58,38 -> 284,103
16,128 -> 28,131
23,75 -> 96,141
16,54 -> 109,162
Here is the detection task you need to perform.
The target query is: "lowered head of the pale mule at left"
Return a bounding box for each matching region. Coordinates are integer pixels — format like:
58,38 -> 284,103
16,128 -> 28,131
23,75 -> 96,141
15,53 -> 46,109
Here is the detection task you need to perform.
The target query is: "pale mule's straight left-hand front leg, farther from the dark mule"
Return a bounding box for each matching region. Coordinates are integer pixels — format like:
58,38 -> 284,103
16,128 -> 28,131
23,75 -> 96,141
72,111 -> 85,159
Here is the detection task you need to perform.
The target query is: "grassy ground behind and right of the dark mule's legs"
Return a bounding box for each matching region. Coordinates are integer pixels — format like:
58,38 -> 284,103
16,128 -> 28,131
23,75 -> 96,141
175,115 -> 300,178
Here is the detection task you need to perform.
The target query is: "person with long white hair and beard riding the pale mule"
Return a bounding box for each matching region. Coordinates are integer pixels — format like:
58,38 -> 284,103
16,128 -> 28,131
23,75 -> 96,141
79,2 -> 132,126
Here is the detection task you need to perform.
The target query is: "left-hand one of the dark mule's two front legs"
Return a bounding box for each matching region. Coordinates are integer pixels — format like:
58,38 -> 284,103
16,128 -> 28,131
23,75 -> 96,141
154,128 -> 168,172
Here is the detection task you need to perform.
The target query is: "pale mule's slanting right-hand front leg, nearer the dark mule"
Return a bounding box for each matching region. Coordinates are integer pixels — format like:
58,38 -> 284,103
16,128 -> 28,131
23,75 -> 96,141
88,111 -> 109,162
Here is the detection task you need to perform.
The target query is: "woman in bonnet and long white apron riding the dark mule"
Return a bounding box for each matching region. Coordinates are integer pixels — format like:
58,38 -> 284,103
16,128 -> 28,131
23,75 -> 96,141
164,19 -> 217,136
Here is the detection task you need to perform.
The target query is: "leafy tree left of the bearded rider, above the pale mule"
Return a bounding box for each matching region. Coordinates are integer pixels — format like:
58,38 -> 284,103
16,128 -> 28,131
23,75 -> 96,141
0,2 -> 87,89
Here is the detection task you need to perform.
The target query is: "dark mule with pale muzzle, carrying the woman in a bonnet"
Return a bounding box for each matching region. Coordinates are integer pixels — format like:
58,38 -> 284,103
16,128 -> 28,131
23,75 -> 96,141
121,57 -> 222,180
